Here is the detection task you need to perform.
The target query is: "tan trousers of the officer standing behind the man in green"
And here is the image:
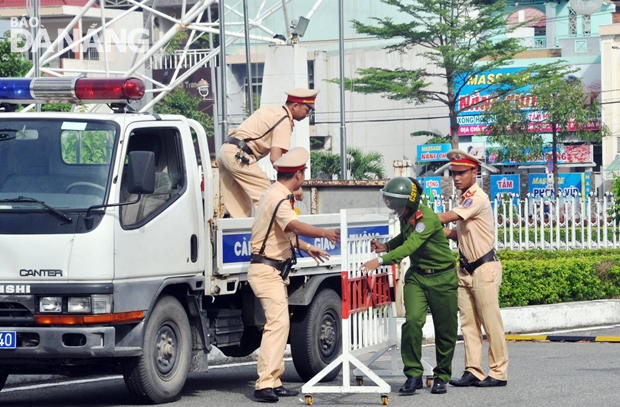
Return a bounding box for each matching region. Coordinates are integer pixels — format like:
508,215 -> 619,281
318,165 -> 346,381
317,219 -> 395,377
458,261 -> 508,380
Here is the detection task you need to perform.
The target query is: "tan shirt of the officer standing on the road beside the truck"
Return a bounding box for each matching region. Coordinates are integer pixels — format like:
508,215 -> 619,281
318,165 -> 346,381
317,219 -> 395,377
250,181 -> 297,260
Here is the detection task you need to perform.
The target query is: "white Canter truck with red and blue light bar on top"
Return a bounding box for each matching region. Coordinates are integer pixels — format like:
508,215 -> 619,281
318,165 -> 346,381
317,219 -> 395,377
0,78 -> 388,403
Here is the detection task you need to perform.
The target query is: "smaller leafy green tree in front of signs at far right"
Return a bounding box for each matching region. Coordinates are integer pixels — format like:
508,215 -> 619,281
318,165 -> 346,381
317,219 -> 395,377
484,71 -> 609,196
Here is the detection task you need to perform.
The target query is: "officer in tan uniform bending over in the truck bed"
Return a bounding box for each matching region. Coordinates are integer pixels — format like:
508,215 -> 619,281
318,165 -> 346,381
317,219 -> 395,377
219,88 -> 319,218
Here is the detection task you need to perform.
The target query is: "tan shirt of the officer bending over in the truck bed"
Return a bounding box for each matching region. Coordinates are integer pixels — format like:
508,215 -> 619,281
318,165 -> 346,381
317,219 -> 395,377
230,106 -> 294,160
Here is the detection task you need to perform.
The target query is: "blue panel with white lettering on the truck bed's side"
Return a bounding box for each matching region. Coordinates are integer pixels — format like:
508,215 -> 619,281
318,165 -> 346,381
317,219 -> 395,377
222,225 -> 389,264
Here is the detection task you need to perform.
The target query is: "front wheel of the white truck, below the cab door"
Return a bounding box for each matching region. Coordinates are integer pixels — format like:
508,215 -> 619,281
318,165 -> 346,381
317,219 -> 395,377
123,296 -> 192,404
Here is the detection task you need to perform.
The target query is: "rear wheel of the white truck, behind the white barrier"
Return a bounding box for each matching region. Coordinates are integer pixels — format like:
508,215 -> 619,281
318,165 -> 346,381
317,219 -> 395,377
290,289 -> 342,382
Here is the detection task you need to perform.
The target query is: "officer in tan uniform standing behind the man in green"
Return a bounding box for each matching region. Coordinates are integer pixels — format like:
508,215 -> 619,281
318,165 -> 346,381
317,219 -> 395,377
437,150 -> 508,387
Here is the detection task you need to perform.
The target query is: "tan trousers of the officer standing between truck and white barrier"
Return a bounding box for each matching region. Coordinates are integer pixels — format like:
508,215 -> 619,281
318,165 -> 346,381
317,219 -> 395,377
248,264 -> 290,390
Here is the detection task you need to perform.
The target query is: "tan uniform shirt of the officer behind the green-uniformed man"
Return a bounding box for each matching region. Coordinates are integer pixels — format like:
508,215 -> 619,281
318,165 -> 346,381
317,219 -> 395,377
452,183 -> 495,263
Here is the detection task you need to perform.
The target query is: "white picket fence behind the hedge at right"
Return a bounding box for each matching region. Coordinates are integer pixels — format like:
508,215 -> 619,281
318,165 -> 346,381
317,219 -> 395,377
422,194 -> 620,250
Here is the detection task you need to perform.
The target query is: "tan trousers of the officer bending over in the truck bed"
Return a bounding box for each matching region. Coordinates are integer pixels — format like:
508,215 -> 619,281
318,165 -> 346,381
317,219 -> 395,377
218,143 -> 271,218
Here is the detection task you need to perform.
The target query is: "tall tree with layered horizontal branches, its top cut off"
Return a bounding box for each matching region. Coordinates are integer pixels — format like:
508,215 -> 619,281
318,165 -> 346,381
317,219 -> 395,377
340,0 -> 554,148
